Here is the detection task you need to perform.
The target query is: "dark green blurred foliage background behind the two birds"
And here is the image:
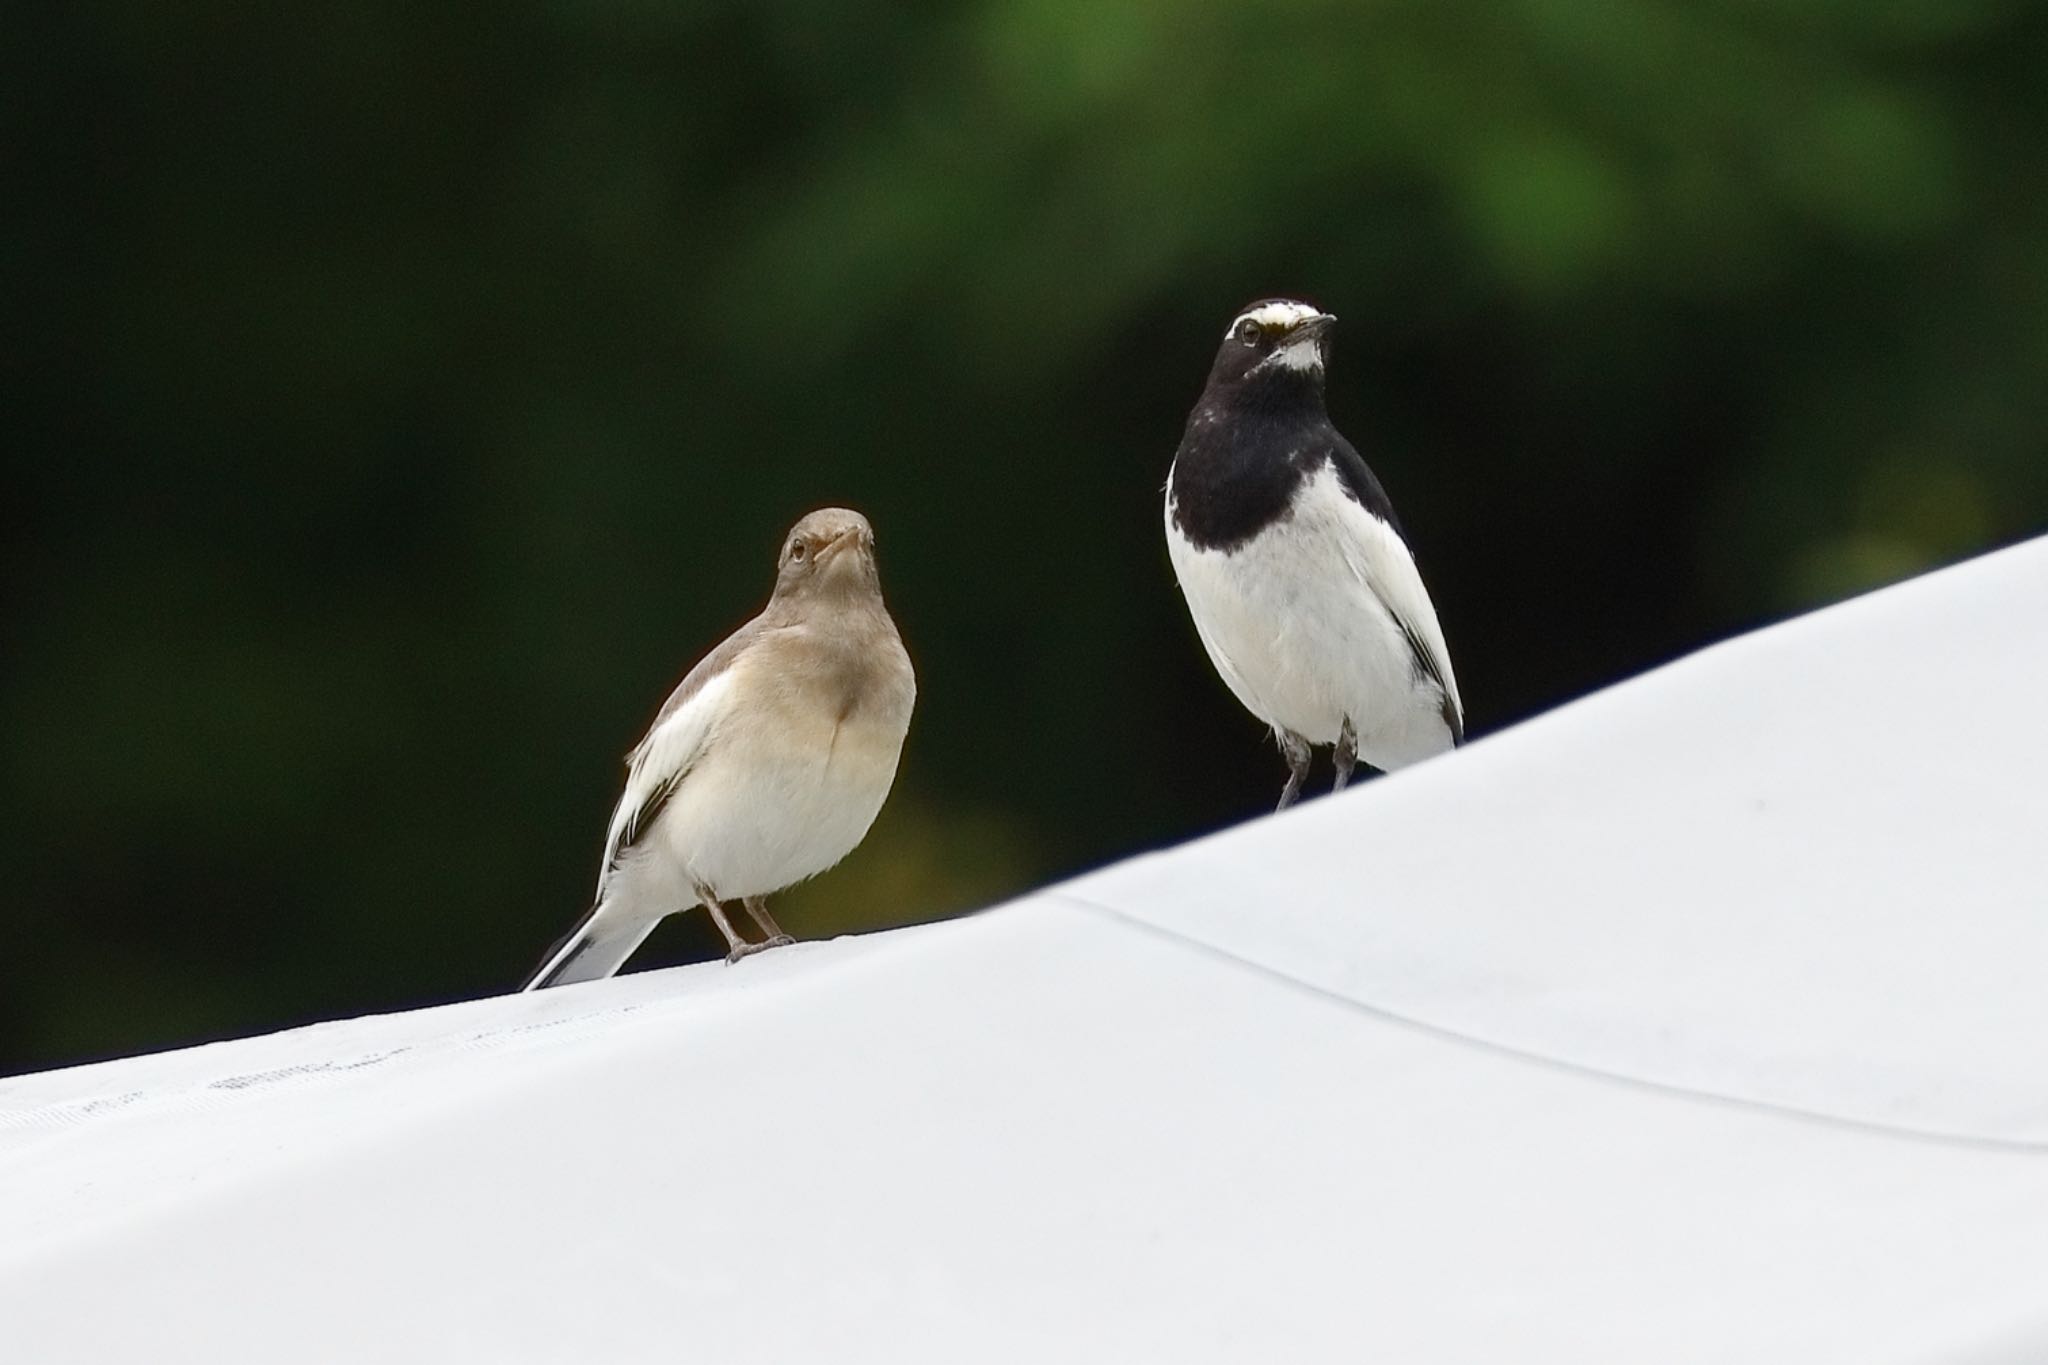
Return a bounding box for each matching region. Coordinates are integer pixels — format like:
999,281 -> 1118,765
0,0 -> 2048,1070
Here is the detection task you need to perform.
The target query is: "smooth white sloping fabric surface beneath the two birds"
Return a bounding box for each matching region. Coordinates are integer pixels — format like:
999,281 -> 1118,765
0,544 -> 2048,1365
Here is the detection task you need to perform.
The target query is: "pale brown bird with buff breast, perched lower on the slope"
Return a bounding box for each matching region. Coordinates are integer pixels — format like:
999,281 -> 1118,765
524,508 -> 918,990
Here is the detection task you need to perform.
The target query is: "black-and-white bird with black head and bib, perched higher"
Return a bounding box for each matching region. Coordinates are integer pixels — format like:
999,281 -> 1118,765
1165,299 -> 1464,810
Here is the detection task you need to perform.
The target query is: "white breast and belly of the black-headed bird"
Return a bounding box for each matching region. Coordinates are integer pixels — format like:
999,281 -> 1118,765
1165,465 -> 1452,767
